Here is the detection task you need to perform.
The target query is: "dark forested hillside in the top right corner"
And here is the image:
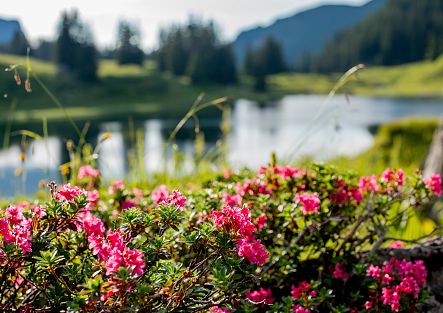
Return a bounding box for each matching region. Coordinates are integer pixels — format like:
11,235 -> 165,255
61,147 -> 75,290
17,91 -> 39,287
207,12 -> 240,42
309,0 -> 443,72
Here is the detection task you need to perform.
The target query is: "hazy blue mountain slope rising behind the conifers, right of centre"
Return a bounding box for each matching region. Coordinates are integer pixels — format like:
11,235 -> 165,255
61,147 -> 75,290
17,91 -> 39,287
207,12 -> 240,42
233,0 -> 385,65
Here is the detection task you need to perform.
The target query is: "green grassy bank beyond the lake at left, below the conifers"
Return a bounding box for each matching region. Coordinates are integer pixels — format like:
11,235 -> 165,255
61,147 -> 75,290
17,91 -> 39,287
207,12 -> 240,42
0,54 -> 278,123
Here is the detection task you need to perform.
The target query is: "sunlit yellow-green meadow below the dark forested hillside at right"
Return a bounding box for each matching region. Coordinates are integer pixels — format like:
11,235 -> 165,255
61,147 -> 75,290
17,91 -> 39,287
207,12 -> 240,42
270,56 -> 443,97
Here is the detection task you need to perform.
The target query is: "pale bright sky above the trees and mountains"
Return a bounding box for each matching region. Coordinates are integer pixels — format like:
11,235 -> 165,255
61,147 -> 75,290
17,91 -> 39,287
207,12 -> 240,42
0,0 -> 367,49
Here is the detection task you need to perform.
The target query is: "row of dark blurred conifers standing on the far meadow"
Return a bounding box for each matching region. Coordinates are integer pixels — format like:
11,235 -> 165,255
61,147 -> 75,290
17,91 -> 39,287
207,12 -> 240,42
7,11 -> 286,91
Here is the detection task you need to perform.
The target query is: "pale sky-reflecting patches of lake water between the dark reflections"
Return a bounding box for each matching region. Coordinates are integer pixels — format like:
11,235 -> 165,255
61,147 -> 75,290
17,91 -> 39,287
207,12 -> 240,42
0,95 -> 443,197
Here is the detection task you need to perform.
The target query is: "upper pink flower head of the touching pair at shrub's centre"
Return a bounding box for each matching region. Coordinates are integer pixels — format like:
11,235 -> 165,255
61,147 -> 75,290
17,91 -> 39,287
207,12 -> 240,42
210,206 -> 254,237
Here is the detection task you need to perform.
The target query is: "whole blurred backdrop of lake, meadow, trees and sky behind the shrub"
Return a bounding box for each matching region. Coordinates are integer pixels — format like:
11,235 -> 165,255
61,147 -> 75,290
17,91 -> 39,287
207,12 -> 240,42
0,0 -> 443,197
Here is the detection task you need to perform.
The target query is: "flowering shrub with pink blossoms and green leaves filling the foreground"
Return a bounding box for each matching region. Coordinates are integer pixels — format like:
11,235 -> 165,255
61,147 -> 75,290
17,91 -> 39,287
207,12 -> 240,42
0,164 -> 441,313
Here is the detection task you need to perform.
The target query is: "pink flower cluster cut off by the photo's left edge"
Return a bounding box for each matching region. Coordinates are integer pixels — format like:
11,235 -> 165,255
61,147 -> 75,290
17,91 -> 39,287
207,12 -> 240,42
0,205 -> 33,255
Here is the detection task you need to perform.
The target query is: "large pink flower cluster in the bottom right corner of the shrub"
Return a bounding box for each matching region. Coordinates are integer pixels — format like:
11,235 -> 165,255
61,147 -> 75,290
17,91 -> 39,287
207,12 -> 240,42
365,258 -> 427,312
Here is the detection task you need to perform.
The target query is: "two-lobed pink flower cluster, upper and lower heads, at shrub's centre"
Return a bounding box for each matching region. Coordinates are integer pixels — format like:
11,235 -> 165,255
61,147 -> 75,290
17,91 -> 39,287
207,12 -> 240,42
210,206 -> 269,266
